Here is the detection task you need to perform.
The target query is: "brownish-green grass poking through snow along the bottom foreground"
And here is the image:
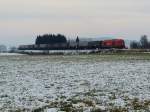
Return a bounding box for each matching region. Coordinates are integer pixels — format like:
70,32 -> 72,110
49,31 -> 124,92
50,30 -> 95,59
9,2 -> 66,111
14,98 -> 150,112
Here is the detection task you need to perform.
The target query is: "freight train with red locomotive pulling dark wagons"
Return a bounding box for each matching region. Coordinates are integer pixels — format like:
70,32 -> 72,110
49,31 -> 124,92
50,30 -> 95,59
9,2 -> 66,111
18,39 -> 125,50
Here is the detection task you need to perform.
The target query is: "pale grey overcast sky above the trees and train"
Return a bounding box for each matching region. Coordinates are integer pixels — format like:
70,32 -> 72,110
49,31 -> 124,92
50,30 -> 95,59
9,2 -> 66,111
0,0 -> 150,45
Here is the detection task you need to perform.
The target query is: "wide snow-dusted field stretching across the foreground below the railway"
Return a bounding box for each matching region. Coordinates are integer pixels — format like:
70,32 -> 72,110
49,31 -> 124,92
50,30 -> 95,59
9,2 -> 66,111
0,55 -> 150,112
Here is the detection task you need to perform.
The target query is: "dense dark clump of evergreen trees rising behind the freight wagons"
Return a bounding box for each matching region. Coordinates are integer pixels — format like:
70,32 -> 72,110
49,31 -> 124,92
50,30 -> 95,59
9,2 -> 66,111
35,34 -> 67,45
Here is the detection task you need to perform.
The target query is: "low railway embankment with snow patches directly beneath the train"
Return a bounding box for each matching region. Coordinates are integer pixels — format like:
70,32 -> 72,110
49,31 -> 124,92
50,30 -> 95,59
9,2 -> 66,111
17,49 -> 150,55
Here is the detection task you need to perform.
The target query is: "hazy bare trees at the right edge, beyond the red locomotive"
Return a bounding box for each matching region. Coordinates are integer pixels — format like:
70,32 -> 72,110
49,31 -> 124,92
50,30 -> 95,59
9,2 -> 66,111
130,35 -> 150,49
